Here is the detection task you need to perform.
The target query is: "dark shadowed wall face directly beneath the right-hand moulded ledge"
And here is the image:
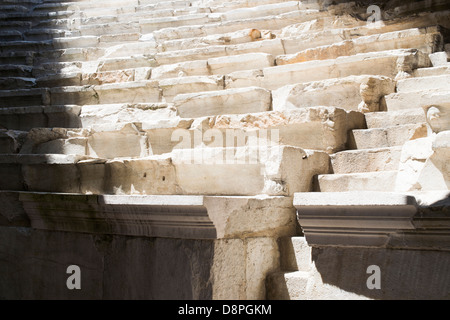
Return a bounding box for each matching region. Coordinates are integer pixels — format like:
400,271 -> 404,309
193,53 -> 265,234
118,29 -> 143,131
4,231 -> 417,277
312,248 -> 450,300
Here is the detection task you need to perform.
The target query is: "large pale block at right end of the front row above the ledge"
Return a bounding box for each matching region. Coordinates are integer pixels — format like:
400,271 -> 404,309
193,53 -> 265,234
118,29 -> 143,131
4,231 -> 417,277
173,146 -> 329,195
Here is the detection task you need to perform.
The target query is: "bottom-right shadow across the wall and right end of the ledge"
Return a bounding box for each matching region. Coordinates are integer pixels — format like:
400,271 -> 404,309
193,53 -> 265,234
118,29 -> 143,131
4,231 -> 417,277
312,194 -> 450,300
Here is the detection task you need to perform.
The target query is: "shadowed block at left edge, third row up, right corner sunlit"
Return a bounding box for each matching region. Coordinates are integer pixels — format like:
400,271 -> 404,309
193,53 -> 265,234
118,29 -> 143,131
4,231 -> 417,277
0,106 -> 81,131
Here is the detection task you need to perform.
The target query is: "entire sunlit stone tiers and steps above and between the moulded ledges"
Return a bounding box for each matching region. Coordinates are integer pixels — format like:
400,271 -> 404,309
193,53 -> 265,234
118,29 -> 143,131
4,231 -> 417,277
0,0 -> 450,299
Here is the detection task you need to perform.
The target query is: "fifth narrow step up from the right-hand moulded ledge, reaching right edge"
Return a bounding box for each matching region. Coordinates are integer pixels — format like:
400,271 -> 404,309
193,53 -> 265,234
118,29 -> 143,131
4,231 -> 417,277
386,89 -> 450,111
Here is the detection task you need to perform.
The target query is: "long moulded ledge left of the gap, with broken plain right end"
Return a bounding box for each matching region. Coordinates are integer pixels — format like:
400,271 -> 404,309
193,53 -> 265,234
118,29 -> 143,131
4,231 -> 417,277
4,191 -> 296,240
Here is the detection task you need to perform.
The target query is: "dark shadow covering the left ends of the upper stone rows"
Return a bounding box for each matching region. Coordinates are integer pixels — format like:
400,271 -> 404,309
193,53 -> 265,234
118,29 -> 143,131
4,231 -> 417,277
0,0 -> 80,131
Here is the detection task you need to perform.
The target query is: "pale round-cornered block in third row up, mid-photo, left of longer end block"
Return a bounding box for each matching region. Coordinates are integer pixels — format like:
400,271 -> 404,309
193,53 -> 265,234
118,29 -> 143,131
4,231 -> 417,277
173,87 -> 272,118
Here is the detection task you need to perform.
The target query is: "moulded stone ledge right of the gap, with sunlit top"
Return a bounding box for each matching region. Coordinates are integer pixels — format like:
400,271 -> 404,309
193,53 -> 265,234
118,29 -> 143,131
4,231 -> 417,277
294,191 -> 450,250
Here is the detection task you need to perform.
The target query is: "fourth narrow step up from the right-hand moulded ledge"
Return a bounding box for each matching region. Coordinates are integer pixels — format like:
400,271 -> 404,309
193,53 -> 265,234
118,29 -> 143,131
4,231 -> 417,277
366,108 -> 427,129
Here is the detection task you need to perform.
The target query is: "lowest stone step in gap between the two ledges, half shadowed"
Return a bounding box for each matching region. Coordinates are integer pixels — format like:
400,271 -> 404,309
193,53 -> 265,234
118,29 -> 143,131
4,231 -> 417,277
266,271 -> 311,300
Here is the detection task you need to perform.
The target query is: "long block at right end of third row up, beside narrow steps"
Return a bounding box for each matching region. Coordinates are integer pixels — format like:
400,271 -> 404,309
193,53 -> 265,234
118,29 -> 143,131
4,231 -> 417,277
273,76 -> 395,112
